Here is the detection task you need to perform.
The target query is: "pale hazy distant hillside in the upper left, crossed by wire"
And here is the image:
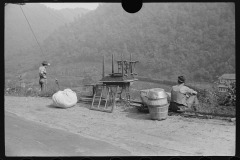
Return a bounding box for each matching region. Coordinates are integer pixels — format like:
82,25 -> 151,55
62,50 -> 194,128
4,3 -> 89,74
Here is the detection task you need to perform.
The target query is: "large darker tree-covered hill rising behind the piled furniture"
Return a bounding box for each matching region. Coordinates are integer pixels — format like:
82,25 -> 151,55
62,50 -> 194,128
5,3 -> 235,81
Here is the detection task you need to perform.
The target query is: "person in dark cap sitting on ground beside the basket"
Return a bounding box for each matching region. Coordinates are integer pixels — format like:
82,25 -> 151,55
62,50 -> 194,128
169,76 -> 199,112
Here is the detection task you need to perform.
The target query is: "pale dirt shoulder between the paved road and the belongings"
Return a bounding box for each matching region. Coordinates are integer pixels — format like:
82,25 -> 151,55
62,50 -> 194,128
5,96 -> 236,156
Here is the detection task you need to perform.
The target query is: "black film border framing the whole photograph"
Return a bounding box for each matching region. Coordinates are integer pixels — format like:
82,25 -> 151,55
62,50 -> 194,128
0,0 -> 240,160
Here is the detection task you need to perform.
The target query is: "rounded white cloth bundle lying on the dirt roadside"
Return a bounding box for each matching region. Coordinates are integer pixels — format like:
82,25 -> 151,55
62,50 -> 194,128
52,89 -> 78,108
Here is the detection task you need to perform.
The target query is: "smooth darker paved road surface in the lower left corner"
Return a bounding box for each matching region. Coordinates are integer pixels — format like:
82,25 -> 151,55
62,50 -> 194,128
5,111 -> 130,157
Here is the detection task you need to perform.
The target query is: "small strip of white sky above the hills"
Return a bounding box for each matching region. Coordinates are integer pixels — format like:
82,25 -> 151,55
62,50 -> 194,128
41,3 -> 98,10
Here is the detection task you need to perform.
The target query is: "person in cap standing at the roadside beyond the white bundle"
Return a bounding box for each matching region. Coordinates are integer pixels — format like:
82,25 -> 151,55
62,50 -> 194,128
39,61 -> 50,92
